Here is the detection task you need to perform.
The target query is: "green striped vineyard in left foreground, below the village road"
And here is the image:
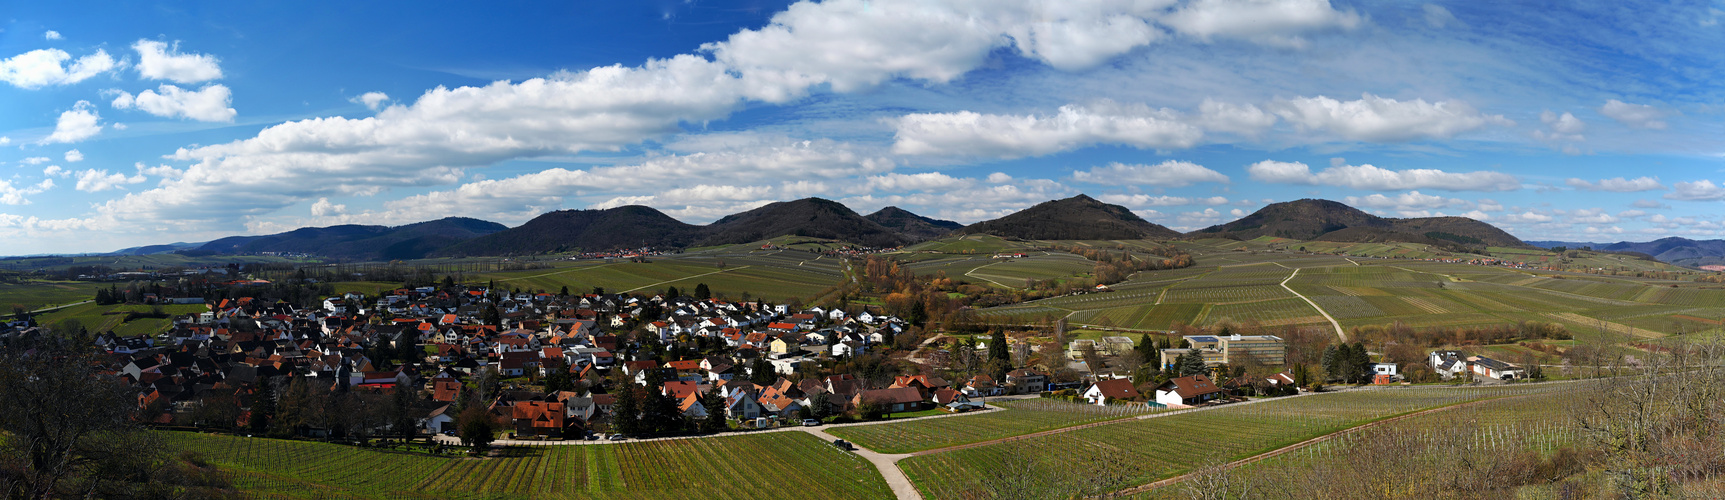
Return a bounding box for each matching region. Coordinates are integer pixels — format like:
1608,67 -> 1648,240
164,431 -> 892,498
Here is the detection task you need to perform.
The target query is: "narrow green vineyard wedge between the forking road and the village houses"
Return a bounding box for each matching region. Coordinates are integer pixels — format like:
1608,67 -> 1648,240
828,398 -> 1149,453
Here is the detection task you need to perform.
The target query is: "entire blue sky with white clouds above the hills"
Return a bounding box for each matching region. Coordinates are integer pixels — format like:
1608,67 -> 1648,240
0,0 -> 1725,255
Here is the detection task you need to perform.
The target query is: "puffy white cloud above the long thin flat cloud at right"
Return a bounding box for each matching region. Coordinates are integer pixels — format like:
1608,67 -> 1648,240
1270,93 -> 1515,141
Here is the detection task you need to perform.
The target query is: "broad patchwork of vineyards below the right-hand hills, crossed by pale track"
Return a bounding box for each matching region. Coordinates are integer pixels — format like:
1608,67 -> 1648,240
978,238 -> 1725,340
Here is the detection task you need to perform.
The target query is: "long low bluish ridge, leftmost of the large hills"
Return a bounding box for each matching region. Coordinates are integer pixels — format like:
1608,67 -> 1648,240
197,217 -> 507,260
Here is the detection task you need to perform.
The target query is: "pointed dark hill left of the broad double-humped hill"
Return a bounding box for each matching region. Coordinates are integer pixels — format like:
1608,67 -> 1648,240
959,195 -> 1180,240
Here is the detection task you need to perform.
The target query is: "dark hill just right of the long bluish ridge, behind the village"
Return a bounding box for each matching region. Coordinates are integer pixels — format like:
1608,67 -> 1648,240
435,205 -> 702,257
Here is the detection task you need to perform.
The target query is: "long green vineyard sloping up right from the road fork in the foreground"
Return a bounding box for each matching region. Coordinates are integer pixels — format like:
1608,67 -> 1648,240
899,384 -> 1561,498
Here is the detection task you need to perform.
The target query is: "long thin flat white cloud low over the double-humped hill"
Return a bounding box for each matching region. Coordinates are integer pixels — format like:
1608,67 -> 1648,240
1245,160 -> 1521,191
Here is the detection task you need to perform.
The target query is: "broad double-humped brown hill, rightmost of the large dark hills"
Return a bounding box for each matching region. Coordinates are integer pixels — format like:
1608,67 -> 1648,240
1187,200 -> 1528,247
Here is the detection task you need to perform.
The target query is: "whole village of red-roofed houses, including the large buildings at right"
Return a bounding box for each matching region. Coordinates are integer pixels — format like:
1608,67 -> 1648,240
0,277 -> 1527,445
